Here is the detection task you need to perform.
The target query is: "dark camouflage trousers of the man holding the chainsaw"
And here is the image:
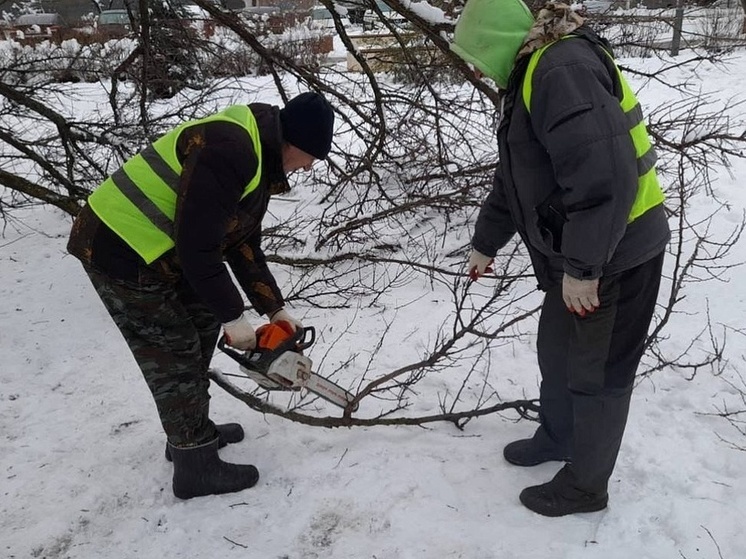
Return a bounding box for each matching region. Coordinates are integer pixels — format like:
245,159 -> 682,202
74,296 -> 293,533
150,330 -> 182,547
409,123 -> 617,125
86,267 -> 220,446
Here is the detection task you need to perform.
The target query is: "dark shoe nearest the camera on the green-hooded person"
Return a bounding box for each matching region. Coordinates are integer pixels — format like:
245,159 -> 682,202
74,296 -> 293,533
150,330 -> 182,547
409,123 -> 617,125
520,465 -> 609,516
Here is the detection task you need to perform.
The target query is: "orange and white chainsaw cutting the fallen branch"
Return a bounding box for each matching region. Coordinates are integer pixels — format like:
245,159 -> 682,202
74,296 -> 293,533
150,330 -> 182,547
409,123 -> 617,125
218,321 -> 358,411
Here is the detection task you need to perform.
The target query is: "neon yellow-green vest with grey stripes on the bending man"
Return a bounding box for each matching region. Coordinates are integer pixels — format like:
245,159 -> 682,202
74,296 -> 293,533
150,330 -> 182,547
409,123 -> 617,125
88,105 -> 262,264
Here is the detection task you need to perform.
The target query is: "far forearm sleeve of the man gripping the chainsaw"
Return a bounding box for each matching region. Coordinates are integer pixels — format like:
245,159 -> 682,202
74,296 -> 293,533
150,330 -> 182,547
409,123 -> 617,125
226,228 -> 285,316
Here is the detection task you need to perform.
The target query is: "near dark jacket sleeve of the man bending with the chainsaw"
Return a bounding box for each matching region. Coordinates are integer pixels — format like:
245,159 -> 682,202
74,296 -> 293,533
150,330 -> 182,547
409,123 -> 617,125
174,123 -> 257,322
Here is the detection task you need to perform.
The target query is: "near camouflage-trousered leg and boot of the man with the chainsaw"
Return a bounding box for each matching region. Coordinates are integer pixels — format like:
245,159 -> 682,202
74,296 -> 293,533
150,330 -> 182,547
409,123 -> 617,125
86,269 -> 259,499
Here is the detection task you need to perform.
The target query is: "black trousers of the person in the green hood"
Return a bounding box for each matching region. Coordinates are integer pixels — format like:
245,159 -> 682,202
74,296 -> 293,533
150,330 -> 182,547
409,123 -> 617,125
537,253 -> 663,492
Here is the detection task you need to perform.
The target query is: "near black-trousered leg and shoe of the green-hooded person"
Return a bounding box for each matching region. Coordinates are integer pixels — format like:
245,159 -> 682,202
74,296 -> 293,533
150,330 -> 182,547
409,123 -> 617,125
521,254 -> 663,516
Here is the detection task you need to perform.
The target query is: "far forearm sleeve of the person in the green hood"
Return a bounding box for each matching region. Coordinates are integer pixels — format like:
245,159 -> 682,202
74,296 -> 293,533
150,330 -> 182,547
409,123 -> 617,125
471,165 -> 516,256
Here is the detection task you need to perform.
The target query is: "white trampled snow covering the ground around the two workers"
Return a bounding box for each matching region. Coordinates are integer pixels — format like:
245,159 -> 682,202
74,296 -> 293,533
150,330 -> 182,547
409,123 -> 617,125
0,47 -> 746,559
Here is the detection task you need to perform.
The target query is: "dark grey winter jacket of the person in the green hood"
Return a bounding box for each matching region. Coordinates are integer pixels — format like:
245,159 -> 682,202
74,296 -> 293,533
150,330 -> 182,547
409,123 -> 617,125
472,28 -> 670,289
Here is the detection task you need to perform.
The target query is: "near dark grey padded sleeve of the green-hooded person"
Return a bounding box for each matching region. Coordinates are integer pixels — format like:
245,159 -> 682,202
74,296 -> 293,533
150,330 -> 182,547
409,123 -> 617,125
531,46 -> 638,279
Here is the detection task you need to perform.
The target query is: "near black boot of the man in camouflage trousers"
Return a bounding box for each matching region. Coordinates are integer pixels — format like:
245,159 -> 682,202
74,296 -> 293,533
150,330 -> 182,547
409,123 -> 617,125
169,437 -> 259,499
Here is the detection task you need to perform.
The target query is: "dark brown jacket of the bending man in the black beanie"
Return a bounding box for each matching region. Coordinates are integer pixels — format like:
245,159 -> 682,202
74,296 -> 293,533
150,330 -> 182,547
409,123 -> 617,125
68,104 -> 288,322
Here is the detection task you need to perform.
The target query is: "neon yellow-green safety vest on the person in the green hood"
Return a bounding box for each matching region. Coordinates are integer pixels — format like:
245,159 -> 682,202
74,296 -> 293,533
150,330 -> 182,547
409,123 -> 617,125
522,35 -> 665,223
